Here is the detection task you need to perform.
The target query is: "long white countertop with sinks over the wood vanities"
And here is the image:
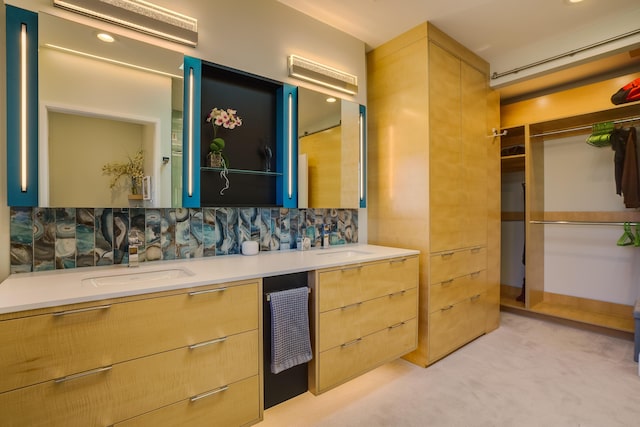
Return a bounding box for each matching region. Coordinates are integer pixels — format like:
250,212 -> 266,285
0,245 -> 419,314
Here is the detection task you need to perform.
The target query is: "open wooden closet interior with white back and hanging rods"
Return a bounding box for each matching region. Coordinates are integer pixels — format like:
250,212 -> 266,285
501,73 -> 640,335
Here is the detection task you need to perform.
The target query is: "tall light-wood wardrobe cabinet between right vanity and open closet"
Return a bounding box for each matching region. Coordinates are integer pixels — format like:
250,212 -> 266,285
367,23 -> 500,366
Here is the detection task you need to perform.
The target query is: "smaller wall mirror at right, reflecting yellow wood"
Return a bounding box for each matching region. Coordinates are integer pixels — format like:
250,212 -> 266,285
298,88 -> 360,208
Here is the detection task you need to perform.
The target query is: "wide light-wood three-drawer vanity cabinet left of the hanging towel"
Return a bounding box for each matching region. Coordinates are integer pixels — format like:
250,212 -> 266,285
0,280 -> 262,426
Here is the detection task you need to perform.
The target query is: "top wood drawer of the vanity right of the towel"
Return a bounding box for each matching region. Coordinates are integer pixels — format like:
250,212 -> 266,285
318,256 -> 418,312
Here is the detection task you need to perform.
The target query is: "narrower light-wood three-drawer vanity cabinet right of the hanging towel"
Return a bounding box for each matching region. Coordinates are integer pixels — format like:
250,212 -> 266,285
309,256 -> 418,394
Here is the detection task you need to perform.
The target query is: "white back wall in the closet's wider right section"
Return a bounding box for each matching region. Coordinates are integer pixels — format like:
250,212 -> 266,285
544,134 -> 640,305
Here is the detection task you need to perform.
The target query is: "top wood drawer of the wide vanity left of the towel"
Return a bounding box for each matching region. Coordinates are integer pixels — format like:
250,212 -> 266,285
0,282 -> 259,392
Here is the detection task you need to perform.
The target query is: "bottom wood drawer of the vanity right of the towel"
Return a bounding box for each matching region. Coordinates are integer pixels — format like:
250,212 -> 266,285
316,319 -> 417,392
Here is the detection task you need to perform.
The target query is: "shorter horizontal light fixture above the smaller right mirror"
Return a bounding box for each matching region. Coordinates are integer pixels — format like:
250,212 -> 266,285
288,55 -> 358,95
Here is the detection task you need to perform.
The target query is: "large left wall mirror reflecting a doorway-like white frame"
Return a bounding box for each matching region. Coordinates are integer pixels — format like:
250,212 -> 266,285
38,13 -> 183,207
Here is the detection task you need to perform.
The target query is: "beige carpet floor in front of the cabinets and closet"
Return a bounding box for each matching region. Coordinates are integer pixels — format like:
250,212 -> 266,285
258,313 -> 640,427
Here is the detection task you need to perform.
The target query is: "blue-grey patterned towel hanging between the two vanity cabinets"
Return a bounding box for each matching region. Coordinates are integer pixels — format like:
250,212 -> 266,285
271,287 -> 312,374
